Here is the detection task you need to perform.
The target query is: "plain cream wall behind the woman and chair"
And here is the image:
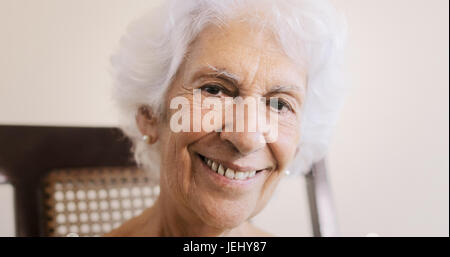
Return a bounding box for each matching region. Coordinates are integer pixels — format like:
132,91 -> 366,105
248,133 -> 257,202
0,0 -> 449,236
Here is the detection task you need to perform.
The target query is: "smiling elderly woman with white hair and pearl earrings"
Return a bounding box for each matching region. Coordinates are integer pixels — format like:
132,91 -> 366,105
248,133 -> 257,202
107,0 -> 344,236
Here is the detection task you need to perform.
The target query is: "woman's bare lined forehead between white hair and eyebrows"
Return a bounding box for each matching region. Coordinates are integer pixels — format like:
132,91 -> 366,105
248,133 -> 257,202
185,22 -> 306,91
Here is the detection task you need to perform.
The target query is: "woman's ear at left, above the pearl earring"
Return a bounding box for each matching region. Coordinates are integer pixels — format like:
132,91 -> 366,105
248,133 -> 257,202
136,105 -> 159,144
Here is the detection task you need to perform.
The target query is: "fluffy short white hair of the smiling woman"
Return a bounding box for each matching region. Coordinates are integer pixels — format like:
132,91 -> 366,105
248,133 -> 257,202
111,0 -> 346,178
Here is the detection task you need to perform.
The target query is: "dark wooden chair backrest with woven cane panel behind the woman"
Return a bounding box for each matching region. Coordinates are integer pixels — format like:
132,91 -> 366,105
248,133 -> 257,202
0,125 -> 337,236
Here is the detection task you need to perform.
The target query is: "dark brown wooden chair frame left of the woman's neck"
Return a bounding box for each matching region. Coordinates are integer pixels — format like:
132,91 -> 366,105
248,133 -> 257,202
0,125 -> 135,236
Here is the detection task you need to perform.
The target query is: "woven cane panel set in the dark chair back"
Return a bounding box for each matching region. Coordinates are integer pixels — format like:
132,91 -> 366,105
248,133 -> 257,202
43,167 -> 159,236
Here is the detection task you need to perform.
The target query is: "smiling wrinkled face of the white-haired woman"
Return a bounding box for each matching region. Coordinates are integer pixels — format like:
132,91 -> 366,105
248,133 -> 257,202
141,20 -> 306,228
